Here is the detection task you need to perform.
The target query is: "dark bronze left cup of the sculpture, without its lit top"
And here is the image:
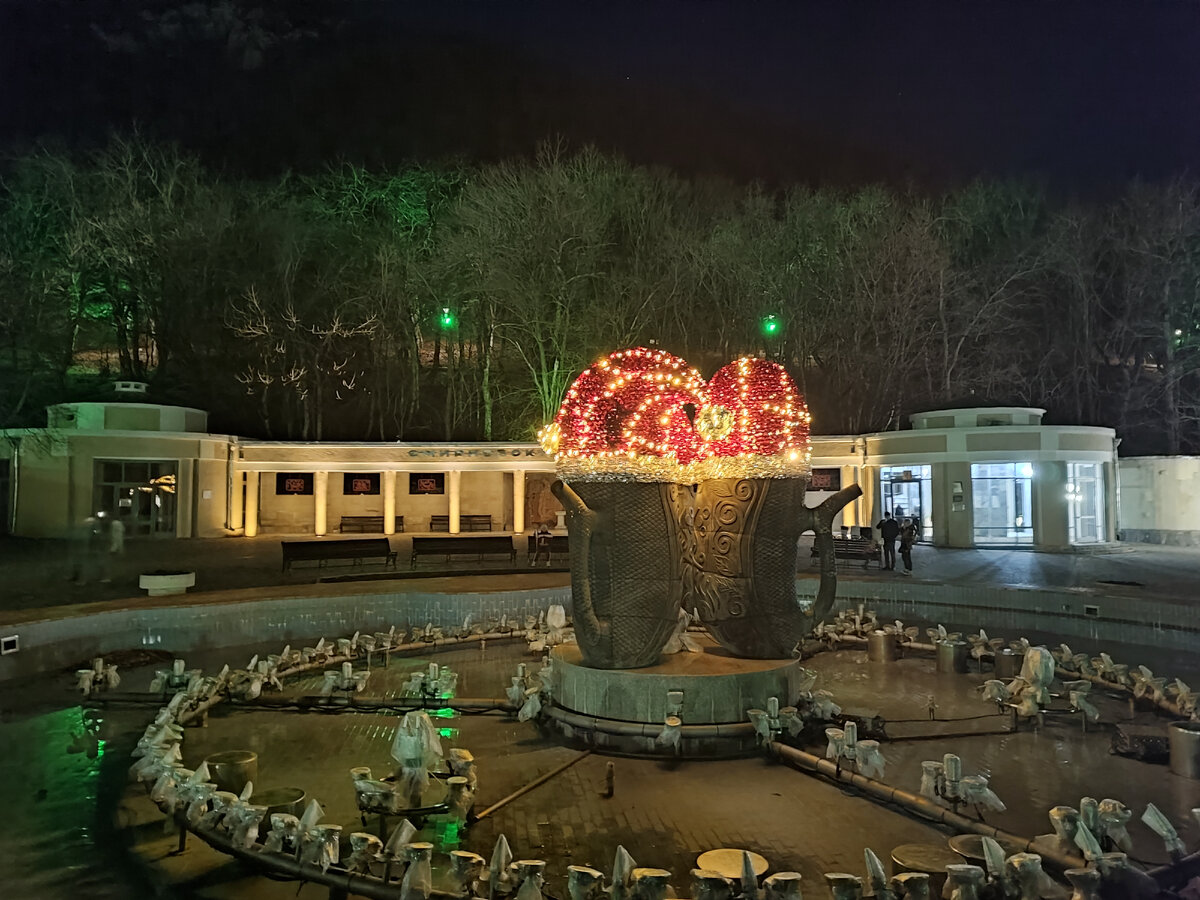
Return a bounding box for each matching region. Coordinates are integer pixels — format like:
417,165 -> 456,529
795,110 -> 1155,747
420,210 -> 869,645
552,481 -> 688,668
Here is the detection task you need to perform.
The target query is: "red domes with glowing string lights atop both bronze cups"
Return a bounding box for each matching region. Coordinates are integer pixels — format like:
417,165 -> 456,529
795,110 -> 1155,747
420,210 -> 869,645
538,347 -> 810,484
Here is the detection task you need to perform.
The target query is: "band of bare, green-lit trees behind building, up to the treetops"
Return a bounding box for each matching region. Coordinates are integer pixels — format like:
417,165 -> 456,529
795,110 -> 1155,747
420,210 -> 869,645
0,140 -> 1200,454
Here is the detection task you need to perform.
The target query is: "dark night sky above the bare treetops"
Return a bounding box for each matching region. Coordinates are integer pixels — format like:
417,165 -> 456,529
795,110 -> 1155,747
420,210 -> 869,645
0,0 -> 1200,193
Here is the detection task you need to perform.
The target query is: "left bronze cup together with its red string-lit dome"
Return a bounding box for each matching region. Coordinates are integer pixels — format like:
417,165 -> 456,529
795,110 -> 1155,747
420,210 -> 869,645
542,349 -> 704,668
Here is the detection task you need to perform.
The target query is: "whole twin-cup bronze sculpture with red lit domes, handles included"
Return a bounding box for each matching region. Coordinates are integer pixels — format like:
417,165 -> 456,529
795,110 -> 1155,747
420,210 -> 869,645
539,348 -> 862,668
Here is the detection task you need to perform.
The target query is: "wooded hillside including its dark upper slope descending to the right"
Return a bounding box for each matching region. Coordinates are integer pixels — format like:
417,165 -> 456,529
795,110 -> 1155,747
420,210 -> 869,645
0,2 -> 1200,454
